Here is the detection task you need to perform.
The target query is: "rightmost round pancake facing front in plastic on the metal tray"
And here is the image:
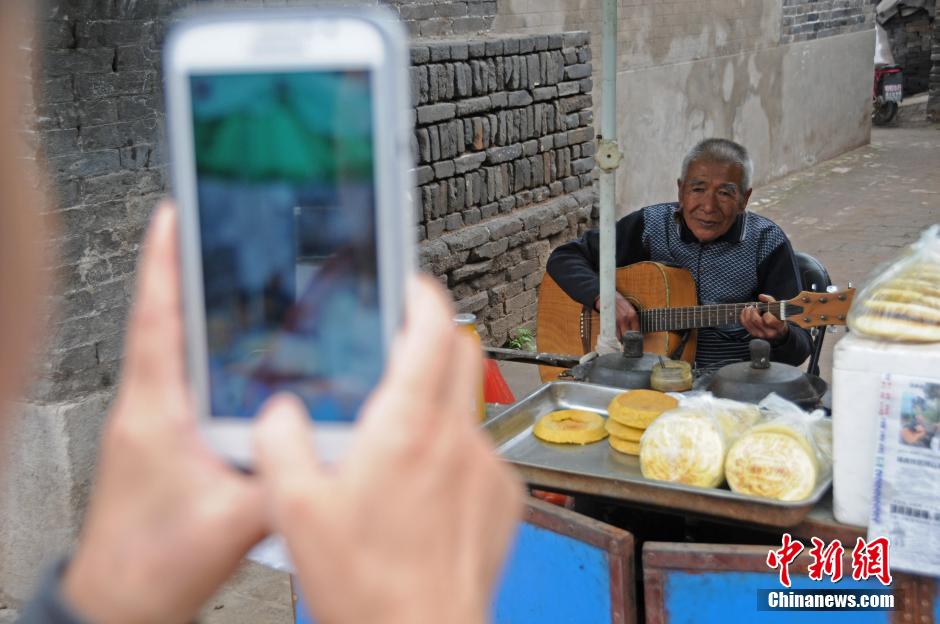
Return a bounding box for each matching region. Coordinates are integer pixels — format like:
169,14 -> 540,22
725,423 -> 819,501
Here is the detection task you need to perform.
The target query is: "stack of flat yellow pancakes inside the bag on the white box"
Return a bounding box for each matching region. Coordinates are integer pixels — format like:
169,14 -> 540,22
849,262 -> 940,342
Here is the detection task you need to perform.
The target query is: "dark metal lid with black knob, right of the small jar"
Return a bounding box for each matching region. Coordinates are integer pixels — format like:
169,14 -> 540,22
708,339 -> 827,409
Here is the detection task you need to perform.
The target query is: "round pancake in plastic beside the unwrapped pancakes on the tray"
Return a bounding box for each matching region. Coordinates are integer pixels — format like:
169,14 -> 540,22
640,408 -> 725,487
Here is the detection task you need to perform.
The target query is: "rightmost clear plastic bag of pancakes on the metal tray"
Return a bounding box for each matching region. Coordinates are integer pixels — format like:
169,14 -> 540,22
725,393 -> 832,501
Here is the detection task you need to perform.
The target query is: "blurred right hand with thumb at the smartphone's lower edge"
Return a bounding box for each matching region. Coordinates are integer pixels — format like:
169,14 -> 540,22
255,278 -> 522,624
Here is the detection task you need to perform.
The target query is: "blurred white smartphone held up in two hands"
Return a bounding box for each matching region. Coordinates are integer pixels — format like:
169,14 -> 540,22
164,9 -> 414,467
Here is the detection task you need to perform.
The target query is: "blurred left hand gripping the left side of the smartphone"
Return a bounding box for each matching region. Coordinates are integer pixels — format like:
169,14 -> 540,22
63,205 -> 265,624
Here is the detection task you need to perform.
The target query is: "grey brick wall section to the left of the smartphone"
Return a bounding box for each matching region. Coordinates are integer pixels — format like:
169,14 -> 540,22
33,7 -> 167,402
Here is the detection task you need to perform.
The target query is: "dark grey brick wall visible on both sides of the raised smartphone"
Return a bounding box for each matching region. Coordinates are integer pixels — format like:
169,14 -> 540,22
32,0 -> 593,403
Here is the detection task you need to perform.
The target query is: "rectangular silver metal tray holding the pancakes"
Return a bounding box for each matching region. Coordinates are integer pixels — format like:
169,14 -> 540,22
483,381 -> 832,527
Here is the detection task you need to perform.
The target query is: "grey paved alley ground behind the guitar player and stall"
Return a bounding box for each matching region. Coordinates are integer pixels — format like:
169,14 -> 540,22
501,101 -> 940,399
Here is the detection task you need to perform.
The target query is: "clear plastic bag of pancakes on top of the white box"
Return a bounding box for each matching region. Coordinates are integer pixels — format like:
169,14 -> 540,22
848,225 -> 940,342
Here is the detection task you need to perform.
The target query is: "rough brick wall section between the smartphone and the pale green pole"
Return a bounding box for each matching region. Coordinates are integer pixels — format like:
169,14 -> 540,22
411,32 -> 594,344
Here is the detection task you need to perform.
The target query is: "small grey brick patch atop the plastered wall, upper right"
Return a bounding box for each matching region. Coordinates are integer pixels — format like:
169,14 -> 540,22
780,0 -> 875,43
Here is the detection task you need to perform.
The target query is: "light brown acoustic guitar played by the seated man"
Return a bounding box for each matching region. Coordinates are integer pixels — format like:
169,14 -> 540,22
536,262 -> 855,381
